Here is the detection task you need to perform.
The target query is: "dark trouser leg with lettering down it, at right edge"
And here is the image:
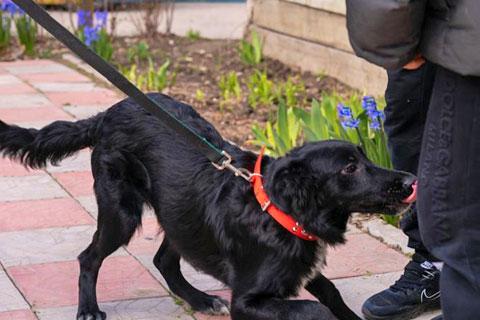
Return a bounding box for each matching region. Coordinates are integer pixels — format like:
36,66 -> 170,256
417,67 -> 480,320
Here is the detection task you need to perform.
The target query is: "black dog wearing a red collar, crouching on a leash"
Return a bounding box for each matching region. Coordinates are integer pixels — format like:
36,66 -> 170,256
0,94 -> 415,320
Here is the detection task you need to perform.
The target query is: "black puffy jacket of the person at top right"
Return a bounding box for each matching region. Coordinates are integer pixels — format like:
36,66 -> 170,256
347,0 -> 480,76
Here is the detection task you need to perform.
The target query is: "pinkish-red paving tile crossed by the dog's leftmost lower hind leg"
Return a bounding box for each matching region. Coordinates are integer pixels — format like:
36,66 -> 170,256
7,256 -> 167,308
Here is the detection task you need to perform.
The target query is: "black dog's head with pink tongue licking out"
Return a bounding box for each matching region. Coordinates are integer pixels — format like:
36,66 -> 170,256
266,141 -> 416,244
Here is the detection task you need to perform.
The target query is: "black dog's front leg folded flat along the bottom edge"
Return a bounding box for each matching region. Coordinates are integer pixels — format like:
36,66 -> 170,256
231,292 -> 338,320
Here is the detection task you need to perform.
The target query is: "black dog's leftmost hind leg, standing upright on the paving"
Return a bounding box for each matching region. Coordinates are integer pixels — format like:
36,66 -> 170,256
77,169 -> 143,320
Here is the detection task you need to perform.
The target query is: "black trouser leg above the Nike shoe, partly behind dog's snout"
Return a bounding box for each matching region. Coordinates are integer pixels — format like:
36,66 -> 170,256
385,62 -> 437,262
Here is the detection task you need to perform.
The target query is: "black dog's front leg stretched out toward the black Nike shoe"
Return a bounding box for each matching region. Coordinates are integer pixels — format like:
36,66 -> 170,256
305,274 -> 360,320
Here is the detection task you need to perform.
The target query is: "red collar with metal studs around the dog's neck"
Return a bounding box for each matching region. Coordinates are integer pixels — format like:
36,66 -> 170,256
252,148 -> 318,241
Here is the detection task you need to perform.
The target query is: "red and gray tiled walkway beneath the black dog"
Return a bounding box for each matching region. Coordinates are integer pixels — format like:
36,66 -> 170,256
0,60 -> 440,320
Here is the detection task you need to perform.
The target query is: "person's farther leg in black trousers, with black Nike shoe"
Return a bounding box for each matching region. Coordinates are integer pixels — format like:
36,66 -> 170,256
362,58 -> 440,320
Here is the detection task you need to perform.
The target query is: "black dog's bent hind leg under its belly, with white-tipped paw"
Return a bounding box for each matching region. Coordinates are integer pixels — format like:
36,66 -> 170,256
153,237 -> 229,315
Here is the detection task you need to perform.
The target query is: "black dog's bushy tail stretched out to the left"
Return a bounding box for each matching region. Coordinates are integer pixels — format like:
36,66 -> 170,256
0,113 -> 103,169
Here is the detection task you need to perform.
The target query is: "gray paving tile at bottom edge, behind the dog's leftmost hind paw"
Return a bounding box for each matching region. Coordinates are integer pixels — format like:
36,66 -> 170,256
36,297 -> 193,320
